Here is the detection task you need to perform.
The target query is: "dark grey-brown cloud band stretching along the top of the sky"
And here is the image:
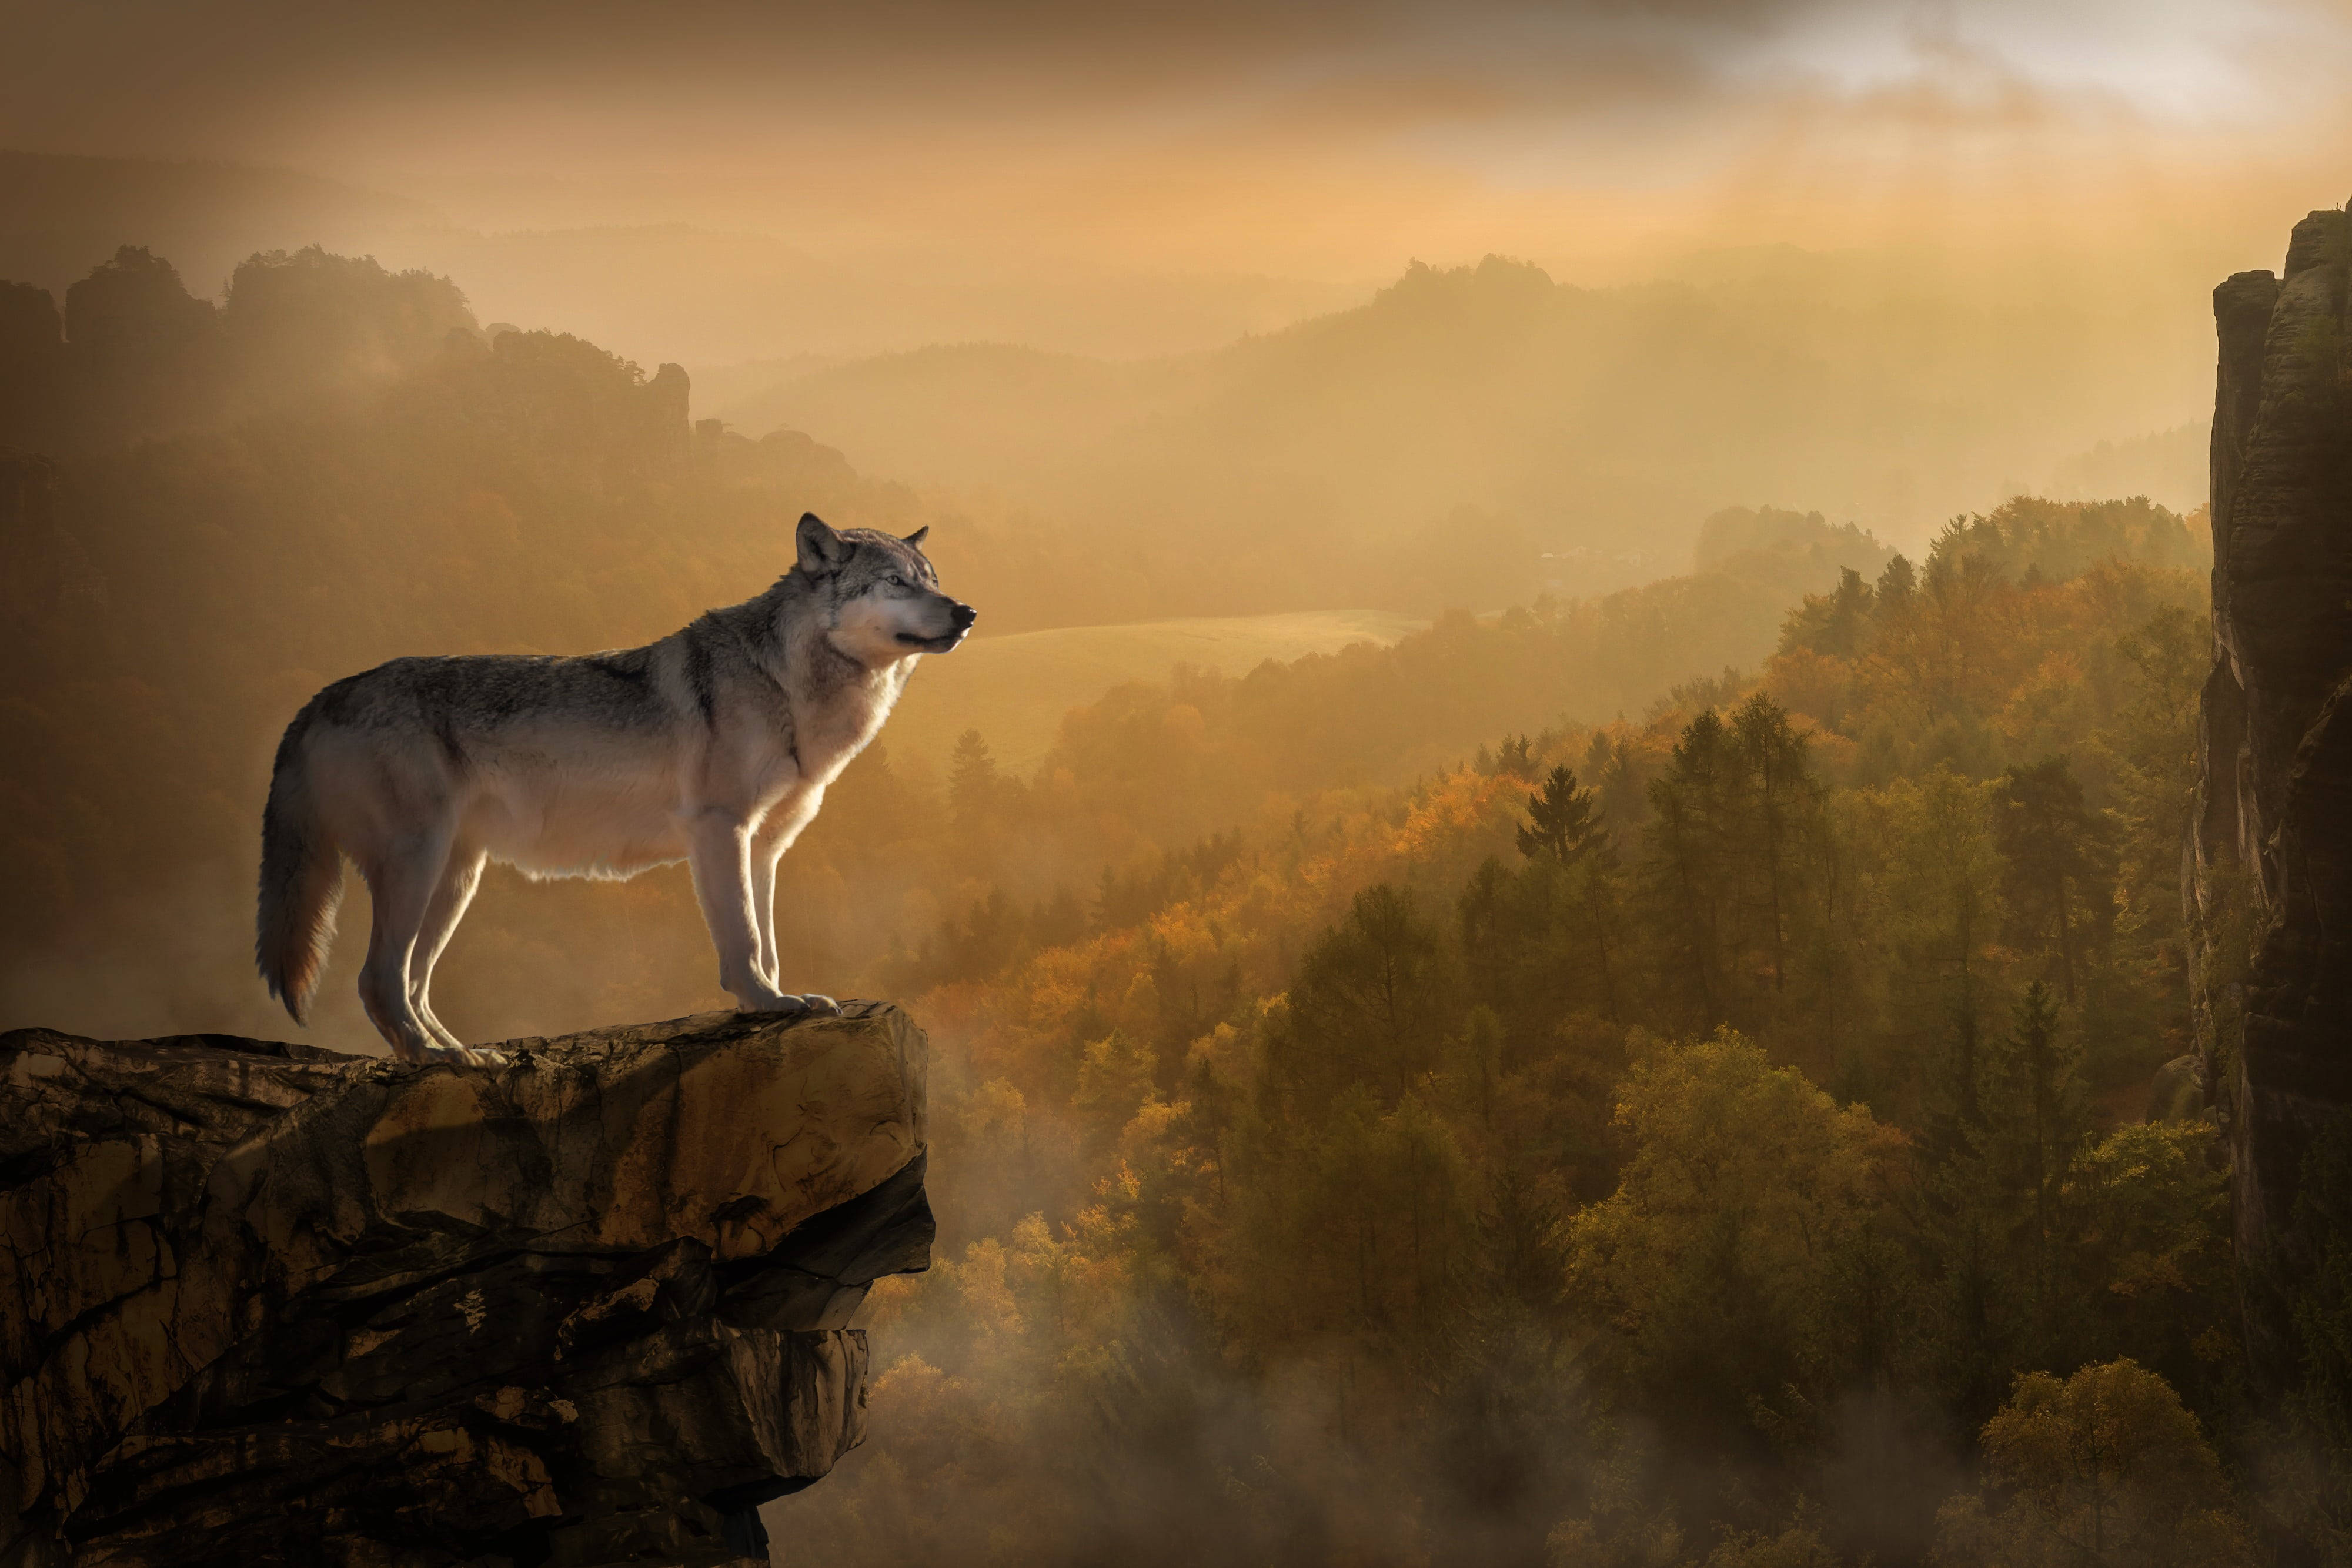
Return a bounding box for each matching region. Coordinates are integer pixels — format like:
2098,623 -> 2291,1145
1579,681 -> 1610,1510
18,0 -> 2340,160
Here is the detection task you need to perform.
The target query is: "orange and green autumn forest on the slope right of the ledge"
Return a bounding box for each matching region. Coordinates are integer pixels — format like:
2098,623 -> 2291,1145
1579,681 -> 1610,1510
807,501 -> 2267,1563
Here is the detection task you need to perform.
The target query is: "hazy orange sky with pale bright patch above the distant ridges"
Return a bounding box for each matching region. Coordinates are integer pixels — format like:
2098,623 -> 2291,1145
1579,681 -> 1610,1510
0,0 -> 2352,291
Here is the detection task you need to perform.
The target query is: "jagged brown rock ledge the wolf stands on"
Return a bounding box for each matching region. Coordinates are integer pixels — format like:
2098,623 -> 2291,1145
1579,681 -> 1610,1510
0,1004 -> 931,1568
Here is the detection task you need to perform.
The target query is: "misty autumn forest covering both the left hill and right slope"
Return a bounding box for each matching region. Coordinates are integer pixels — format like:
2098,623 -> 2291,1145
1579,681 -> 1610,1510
0,249 -> 2314,1568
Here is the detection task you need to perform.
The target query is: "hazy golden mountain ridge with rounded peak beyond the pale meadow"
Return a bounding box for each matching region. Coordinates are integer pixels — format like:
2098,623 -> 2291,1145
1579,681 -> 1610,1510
715,256 -> 2180,576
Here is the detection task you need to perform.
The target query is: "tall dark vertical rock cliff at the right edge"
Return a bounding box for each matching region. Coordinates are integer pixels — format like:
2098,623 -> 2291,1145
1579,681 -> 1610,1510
2187,212 -> 2352,1378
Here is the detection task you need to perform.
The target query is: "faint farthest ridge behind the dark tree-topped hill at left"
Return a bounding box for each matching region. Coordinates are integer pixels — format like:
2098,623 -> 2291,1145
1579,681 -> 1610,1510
0,151 -> 1355,372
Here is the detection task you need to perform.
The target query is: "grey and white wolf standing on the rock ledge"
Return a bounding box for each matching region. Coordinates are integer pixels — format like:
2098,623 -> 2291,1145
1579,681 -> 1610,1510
254,513 -> 978,1060
